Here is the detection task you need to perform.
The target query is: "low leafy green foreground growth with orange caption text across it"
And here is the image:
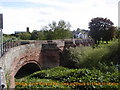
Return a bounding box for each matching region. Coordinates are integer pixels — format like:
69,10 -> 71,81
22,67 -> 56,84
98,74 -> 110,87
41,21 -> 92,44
16,67 -> 119,89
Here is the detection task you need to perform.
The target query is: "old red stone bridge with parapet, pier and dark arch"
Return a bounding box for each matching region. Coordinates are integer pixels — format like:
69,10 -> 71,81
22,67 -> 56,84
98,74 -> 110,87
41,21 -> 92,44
0,40 -> 94,88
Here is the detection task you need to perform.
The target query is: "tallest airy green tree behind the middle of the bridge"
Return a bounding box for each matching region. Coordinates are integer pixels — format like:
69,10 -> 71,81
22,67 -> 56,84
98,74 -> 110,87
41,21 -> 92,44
42,20 -> 72,40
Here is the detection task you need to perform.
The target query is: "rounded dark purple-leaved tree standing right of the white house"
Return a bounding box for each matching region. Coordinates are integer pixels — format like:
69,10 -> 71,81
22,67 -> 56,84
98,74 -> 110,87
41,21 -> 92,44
89,17 -> 115,44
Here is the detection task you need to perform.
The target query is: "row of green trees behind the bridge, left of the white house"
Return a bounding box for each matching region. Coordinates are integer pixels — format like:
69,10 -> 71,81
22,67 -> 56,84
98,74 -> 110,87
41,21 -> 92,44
16,20 -> 73,40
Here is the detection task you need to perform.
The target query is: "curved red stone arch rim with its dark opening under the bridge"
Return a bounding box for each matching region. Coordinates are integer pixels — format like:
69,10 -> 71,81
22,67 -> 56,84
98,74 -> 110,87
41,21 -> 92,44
10,60 -> 41,88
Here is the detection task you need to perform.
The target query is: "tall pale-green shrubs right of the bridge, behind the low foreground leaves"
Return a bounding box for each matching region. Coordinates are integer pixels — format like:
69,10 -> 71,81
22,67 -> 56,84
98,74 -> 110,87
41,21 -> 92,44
61,40 -> 120,72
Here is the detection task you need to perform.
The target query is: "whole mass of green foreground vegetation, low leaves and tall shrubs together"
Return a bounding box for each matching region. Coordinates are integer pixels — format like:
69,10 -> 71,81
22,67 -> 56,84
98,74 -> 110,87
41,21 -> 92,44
16,40 -> 120,90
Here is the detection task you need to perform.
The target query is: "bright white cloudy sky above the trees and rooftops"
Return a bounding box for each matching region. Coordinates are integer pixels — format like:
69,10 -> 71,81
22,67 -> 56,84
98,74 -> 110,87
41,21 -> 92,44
0,0 -> 119,34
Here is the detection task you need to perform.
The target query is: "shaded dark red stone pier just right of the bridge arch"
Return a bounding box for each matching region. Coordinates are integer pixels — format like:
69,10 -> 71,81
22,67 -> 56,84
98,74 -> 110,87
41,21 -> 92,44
41,43 -> 60,69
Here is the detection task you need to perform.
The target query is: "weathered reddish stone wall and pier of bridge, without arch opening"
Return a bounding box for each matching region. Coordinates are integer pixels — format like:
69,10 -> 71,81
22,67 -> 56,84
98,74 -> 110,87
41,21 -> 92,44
0,43 -> 59,88
